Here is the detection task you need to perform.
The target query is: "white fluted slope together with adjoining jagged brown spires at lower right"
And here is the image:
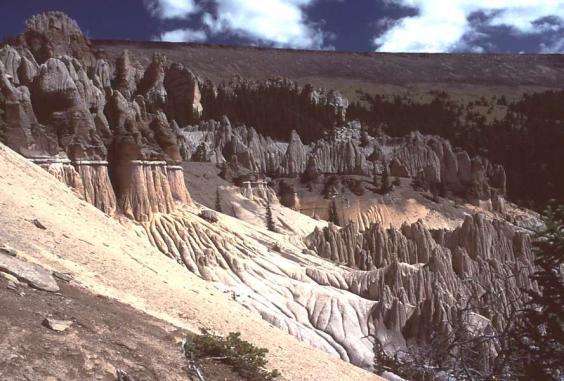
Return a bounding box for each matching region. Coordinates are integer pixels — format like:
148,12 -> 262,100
134,202 -> 534,367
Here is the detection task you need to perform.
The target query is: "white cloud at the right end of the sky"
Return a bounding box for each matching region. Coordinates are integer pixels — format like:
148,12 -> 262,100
374,0 -> 564,53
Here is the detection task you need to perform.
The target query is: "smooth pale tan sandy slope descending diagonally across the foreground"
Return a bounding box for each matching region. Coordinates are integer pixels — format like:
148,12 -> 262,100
0,145 -> 377,380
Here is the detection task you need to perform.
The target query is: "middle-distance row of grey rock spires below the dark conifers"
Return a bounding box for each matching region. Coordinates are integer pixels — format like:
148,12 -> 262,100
179,117 -> 506,208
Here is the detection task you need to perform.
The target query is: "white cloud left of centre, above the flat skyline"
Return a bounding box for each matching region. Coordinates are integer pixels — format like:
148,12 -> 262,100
149,0 -> 332,49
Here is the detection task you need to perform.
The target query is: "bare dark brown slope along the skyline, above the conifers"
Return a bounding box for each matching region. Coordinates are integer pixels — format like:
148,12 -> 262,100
92,41 -> 564,95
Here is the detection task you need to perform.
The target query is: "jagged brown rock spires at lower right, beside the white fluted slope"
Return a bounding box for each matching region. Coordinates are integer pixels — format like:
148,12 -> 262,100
309,214 -> 535,354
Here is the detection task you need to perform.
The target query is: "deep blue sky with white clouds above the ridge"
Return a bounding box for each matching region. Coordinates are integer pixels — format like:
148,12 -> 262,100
0,0 -> 564,53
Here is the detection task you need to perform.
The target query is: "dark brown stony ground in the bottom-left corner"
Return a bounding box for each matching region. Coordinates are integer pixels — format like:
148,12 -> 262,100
0,277 -> 244,381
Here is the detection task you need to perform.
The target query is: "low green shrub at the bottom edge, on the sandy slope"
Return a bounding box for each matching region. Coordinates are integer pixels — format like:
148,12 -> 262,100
183,329 -> 280,381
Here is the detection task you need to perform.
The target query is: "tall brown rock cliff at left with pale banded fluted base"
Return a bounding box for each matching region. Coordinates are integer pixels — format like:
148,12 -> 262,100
0,12 -> 191,219
